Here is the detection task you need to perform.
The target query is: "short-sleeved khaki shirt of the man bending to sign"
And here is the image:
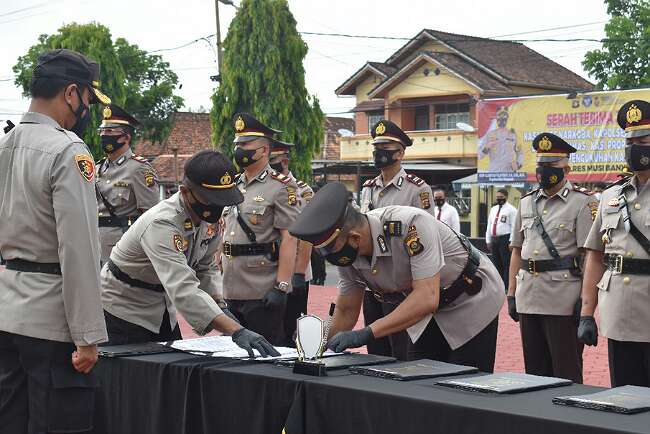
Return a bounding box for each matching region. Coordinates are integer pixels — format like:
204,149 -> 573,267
338,206 -> 505,349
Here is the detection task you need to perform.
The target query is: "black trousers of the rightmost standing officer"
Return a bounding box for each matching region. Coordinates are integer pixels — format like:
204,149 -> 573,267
607,339 -> 650,387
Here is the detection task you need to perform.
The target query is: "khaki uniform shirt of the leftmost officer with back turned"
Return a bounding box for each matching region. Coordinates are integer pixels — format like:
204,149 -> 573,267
0,112 -> 107,345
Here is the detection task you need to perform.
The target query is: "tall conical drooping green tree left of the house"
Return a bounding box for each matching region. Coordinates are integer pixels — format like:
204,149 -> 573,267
210,0 -> 323,179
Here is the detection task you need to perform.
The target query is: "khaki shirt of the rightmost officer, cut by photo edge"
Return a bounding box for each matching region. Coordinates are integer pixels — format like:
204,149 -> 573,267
584,177 -> 650,342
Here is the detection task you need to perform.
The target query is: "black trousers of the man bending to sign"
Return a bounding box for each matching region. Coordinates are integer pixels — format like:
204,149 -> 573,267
408,316 -> 499,372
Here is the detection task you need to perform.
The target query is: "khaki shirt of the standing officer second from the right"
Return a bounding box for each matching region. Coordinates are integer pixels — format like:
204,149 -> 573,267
510,181 -> 598,315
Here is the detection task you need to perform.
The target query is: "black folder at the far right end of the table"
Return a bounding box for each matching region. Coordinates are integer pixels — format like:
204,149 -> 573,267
553,386 -> 650,414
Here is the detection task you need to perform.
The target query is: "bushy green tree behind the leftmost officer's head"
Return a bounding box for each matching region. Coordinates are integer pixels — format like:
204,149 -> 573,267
13,23 -> 183,158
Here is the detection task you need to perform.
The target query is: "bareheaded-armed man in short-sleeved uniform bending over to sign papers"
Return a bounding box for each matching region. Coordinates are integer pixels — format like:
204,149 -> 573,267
290,183 -> 505,372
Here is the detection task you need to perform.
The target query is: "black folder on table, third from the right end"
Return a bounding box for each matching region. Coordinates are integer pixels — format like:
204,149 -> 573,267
350,359 -> 478,381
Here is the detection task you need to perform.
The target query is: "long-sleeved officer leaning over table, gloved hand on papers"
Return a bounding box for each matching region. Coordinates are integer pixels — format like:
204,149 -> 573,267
101,150 -> 278,355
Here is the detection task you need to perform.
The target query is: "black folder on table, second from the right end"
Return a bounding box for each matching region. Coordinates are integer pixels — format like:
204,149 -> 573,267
436,372 -> 571,393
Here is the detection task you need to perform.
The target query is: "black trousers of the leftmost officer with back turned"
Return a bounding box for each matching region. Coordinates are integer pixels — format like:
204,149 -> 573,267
0,331 -> 98,434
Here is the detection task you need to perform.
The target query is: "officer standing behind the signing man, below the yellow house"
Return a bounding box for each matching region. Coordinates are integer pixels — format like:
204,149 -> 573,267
361,119 -> 433,360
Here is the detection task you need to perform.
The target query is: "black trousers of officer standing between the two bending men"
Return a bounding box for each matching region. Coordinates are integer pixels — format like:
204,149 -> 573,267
226,300 -> 287,346
